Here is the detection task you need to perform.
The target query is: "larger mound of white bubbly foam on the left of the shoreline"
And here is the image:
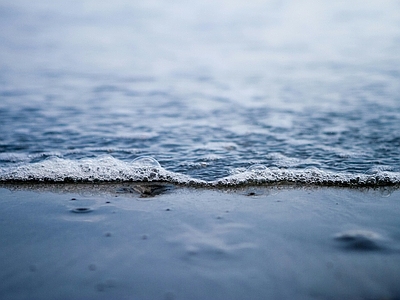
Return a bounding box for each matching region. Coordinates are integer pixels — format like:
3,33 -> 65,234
0,155 -> 205,184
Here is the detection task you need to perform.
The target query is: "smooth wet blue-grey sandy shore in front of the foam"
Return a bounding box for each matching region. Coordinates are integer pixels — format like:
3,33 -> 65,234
0,184 -> 400,300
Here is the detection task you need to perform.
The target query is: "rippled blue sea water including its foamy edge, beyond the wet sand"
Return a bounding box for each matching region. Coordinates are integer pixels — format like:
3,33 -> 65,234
0,0 -> 400,186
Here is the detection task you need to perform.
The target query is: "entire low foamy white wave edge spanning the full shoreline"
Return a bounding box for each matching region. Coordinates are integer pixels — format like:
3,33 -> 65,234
0,155 -> 400,187
